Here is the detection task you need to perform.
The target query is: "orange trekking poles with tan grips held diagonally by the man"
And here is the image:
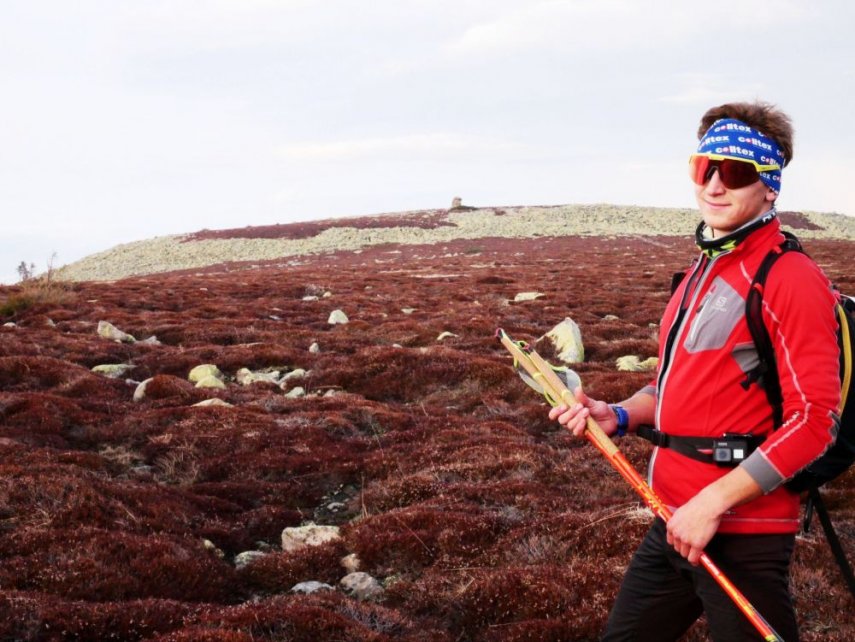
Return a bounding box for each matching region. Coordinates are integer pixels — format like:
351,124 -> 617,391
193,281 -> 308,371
496,328 -> 784,642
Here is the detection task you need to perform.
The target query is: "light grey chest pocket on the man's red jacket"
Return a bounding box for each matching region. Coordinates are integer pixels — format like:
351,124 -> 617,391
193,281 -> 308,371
683,276 -> 745,353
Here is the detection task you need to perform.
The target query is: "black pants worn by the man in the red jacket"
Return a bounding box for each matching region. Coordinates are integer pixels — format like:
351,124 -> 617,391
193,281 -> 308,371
603,519 -> 798,642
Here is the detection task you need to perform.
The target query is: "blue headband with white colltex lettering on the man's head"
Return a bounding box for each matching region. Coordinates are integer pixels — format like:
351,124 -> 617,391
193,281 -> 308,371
697,118 -> 784,194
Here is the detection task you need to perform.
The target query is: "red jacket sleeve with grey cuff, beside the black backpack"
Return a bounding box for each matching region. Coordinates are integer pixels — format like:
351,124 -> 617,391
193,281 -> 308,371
742,252 -> 840,493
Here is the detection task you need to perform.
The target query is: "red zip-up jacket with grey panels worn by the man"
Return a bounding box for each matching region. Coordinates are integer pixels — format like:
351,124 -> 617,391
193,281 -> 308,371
649,212 -> 840,533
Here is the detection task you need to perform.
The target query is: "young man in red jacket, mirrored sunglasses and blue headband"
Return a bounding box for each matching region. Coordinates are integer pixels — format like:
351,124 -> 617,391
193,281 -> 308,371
549,103 -> 840,642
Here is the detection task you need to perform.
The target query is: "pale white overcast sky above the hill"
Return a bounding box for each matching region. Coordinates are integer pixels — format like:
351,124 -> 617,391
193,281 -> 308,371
0,0 -> 855,282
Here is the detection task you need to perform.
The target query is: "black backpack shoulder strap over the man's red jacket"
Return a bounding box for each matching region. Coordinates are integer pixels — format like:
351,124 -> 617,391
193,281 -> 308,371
742,232 -> 804,428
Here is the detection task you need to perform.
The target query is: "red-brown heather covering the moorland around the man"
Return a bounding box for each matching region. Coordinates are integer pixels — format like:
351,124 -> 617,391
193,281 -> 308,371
0,209 -> 855,642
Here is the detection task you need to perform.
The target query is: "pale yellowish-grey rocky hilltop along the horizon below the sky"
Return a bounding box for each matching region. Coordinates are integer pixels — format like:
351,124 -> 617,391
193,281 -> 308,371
58,205 -> 855,281
